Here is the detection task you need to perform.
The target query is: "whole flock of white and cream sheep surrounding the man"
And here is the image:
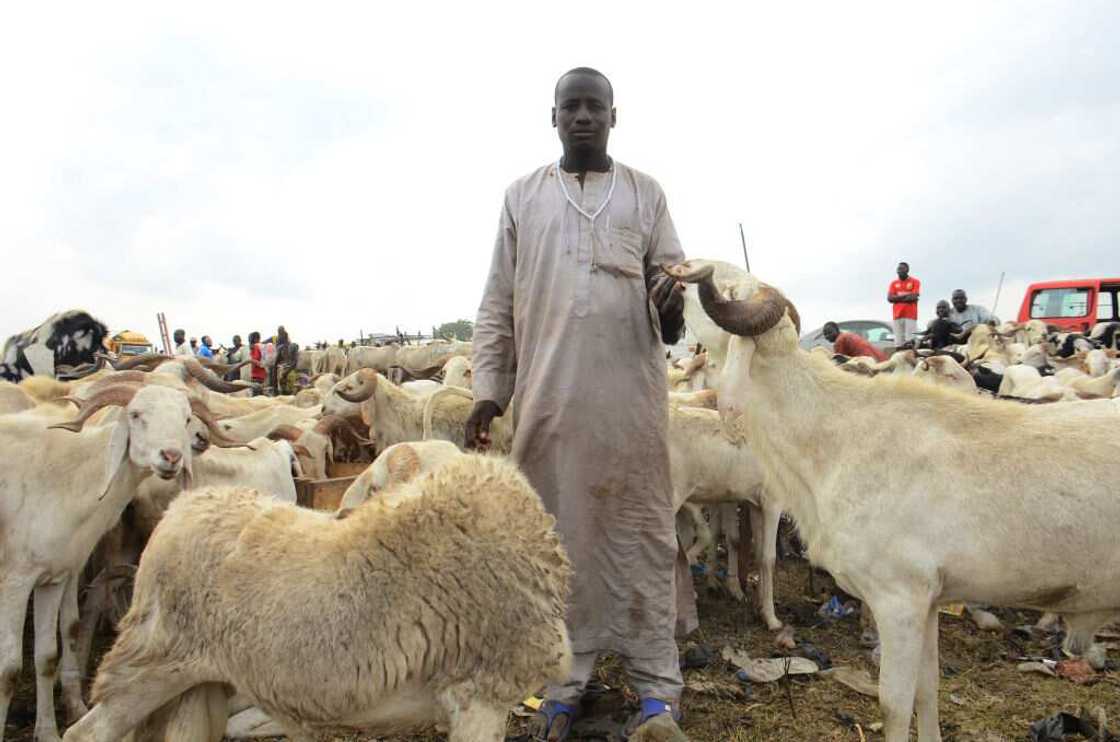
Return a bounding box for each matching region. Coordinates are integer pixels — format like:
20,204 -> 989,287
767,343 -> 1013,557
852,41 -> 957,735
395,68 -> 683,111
0,260 -> 1120,742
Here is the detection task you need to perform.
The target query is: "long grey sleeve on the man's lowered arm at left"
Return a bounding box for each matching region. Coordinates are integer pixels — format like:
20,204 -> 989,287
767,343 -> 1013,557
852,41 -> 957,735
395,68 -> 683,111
470,192 -> 517,411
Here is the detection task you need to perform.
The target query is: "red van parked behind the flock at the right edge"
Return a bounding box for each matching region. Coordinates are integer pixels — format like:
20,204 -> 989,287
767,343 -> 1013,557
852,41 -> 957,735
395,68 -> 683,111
1019,278 -> 1120,332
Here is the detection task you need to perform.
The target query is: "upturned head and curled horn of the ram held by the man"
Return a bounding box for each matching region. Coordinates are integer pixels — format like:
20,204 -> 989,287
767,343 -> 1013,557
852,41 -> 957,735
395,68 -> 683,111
663,260 -> 801,337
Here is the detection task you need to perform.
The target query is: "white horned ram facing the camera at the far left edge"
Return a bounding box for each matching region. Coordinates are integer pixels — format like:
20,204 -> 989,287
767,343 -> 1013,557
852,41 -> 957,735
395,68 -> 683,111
0,384 -> 203,740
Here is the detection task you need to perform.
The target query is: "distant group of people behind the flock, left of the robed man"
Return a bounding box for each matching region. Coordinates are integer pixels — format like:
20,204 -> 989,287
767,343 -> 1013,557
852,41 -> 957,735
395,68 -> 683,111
171,325 -> 299,395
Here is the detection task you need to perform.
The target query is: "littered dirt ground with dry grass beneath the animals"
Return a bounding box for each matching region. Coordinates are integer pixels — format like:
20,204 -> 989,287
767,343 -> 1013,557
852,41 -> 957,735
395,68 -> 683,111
6,560 -> 1120,742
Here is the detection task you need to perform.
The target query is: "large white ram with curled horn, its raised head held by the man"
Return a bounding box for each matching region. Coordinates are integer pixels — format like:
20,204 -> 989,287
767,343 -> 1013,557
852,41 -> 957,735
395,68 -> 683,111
666,261 -> 1120,742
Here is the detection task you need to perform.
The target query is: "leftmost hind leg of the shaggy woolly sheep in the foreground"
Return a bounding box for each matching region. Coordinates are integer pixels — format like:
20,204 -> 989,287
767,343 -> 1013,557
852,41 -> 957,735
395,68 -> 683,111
63,668 -> 205,742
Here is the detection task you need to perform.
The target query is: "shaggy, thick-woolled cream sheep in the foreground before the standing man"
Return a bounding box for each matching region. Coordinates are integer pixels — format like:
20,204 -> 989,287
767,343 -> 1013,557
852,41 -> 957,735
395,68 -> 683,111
65,455 -> 571,742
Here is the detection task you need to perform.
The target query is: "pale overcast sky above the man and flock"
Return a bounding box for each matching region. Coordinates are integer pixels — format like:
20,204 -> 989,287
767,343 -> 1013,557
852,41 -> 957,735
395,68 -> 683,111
0,1 -> 1120,344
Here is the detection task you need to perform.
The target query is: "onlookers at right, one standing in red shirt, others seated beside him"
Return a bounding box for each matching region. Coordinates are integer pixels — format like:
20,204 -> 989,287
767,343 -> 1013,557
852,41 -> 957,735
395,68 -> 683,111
822,261 -> 999,361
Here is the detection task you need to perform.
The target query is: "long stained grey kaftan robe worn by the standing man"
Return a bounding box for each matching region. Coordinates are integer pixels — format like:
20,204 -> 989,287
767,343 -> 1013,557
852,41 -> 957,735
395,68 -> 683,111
473,161 -> 696,661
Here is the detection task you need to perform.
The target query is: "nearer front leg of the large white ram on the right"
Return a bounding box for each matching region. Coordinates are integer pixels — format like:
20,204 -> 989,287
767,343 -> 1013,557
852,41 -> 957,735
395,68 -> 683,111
868,596 -> 932,742
